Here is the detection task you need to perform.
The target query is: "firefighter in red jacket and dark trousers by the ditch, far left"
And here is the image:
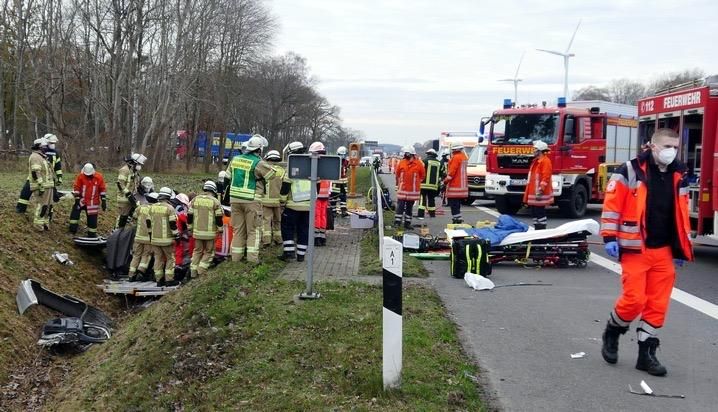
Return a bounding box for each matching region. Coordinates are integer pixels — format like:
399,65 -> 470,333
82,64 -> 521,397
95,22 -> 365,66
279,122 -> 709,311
70,163 -> 107,237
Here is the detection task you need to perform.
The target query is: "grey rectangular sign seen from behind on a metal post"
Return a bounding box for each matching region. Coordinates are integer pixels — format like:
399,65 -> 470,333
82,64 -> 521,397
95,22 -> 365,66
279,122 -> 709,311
287,154 -> 341,299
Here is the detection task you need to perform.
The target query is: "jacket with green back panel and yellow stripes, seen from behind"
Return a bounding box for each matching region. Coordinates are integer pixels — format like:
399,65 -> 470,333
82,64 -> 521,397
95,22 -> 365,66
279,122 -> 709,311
227,153 -> 276,203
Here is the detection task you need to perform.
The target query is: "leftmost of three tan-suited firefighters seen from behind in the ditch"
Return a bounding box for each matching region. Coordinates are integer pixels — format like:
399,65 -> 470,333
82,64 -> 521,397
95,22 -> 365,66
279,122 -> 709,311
128,195 -> 157,282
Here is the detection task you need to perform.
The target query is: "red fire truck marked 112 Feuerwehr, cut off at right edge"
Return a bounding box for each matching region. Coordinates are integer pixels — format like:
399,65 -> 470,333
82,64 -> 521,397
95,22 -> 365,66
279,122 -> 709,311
638,76 -> 718,246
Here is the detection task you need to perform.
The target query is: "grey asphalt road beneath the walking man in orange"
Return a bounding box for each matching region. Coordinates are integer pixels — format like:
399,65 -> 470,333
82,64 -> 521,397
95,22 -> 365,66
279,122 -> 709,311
383,169 -> 718,411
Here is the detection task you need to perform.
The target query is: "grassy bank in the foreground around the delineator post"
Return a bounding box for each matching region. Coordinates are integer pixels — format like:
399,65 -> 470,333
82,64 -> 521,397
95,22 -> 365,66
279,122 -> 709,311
51,254 -> 481,411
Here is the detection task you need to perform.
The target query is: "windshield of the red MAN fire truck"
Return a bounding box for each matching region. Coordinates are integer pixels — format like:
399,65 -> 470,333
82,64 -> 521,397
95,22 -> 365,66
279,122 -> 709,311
491,114 -> 558,145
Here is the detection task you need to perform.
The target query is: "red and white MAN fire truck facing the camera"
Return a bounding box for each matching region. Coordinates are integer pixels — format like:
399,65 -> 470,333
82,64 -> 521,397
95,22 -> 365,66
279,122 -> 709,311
481,98 -> 641,218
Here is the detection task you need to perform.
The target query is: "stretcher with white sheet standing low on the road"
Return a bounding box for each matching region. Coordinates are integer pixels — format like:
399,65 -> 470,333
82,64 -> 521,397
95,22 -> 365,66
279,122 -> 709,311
444,219 -> 600,268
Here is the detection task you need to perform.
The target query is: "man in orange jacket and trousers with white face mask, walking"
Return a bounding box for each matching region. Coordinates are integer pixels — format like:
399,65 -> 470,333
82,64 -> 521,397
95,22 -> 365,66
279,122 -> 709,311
601,129 -> 693,376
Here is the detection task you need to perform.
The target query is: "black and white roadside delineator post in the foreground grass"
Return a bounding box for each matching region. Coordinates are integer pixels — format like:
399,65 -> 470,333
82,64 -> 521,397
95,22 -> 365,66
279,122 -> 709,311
379,237 -> 403,390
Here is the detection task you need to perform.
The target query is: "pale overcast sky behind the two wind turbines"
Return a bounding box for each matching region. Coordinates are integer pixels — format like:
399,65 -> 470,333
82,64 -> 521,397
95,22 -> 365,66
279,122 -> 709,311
269,0 -> 718,144
